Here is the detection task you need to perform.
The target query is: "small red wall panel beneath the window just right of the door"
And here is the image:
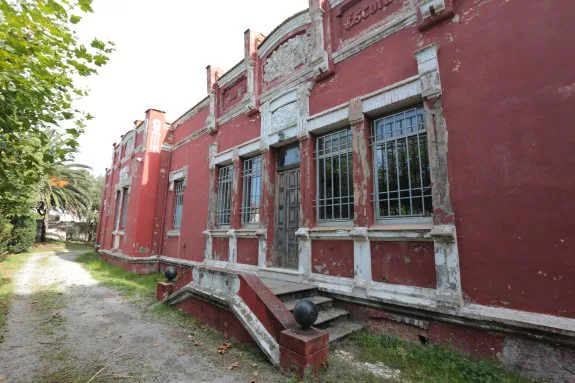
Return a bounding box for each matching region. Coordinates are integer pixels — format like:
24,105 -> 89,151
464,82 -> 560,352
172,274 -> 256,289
311,240 -> 354,278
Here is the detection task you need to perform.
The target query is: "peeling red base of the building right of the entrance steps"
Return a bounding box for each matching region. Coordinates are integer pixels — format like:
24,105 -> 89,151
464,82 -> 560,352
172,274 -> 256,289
336,301 -> 575,382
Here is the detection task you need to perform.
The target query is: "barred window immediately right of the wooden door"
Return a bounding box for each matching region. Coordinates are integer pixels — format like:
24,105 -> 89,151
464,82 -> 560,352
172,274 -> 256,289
316,128 -> 353,221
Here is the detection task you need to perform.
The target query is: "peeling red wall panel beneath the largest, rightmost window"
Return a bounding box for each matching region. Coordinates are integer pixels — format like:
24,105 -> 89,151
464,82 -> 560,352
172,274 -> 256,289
370,242 -> 436,288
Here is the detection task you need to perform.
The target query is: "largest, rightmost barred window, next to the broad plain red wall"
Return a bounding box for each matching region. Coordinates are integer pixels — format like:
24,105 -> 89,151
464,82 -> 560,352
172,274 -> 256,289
373,106 -> 432,219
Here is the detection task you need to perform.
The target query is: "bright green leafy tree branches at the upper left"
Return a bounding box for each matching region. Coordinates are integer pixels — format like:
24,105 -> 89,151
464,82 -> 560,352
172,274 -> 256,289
0,0 -> 113,224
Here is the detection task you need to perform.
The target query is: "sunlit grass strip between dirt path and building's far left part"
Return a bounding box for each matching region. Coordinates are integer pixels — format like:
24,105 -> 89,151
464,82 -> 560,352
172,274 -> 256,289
76,252 -> 164,299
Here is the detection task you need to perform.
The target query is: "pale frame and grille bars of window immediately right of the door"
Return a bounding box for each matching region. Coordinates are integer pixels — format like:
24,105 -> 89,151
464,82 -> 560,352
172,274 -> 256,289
314,126 -> 355,226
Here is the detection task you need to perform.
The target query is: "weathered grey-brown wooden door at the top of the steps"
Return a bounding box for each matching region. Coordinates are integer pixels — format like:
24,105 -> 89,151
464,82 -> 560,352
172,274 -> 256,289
274,169 -> 300,269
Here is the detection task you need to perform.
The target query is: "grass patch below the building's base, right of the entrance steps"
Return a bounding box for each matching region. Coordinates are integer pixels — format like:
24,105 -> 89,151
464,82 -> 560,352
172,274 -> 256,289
332,331 -> 533,383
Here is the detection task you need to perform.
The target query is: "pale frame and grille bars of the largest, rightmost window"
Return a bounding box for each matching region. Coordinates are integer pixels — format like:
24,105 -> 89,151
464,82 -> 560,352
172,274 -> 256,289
371,103 -> 433,225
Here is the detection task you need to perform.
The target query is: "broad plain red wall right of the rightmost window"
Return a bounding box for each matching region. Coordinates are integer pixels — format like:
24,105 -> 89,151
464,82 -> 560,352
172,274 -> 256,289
432,0 -> 575,317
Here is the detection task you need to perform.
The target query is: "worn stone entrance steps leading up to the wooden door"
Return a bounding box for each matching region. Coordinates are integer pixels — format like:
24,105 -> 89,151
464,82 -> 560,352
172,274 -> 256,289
261,278 -> 363,343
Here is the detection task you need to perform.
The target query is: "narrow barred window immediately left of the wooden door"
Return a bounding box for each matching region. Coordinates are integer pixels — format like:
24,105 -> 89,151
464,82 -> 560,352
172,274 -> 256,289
242,156 -> 262,224
